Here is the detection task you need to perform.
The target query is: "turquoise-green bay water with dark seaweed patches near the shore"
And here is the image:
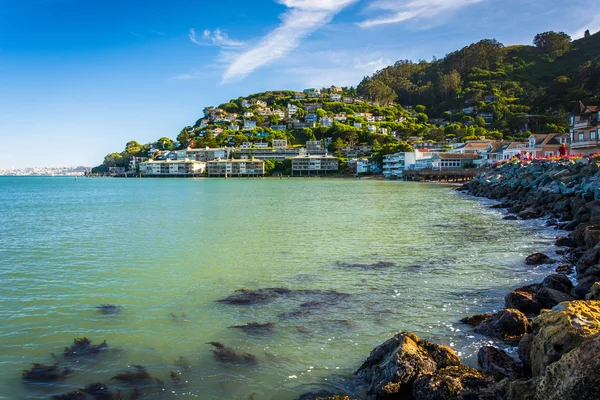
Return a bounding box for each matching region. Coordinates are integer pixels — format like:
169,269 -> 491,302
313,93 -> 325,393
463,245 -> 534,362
0,177 -> 556,399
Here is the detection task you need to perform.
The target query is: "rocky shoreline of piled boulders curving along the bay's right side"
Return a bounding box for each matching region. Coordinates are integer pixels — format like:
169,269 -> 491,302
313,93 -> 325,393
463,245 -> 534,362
300,157 -> 600,400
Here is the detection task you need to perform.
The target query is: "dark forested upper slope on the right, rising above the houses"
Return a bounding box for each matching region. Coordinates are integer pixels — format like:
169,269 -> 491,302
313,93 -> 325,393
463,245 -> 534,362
358,32 -> 600,132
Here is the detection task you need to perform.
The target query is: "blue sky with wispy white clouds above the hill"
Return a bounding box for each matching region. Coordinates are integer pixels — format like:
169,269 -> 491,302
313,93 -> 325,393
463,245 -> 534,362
0,0 -> 600,168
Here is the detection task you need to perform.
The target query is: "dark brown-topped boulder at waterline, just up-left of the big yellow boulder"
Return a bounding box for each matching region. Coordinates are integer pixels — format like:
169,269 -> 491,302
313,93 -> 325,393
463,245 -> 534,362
475,308 -> 531,342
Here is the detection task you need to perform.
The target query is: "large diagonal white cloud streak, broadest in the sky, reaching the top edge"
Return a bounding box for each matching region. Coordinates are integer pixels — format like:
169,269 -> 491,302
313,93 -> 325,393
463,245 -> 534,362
223,0 -> 357,82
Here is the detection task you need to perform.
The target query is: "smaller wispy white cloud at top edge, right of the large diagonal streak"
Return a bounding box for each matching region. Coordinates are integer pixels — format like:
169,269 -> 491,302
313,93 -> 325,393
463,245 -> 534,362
358,0 -> 485,28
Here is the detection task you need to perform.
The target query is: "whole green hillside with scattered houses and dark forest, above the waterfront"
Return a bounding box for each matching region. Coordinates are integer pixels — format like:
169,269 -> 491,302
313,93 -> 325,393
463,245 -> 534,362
95,32 -> 600,172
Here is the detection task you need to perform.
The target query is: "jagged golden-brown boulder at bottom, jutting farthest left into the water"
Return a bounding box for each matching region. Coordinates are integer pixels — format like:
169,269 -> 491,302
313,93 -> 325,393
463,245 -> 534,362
356,332 -> 461,399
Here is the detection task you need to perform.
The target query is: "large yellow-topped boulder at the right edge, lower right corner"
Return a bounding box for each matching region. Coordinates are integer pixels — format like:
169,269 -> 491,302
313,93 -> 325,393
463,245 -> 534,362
527,301 -> 600,377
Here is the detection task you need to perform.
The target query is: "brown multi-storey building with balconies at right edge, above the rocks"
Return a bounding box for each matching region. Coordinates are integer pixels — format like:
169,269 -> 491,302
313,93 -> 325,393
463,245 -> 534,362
569,101 -> 600,155
